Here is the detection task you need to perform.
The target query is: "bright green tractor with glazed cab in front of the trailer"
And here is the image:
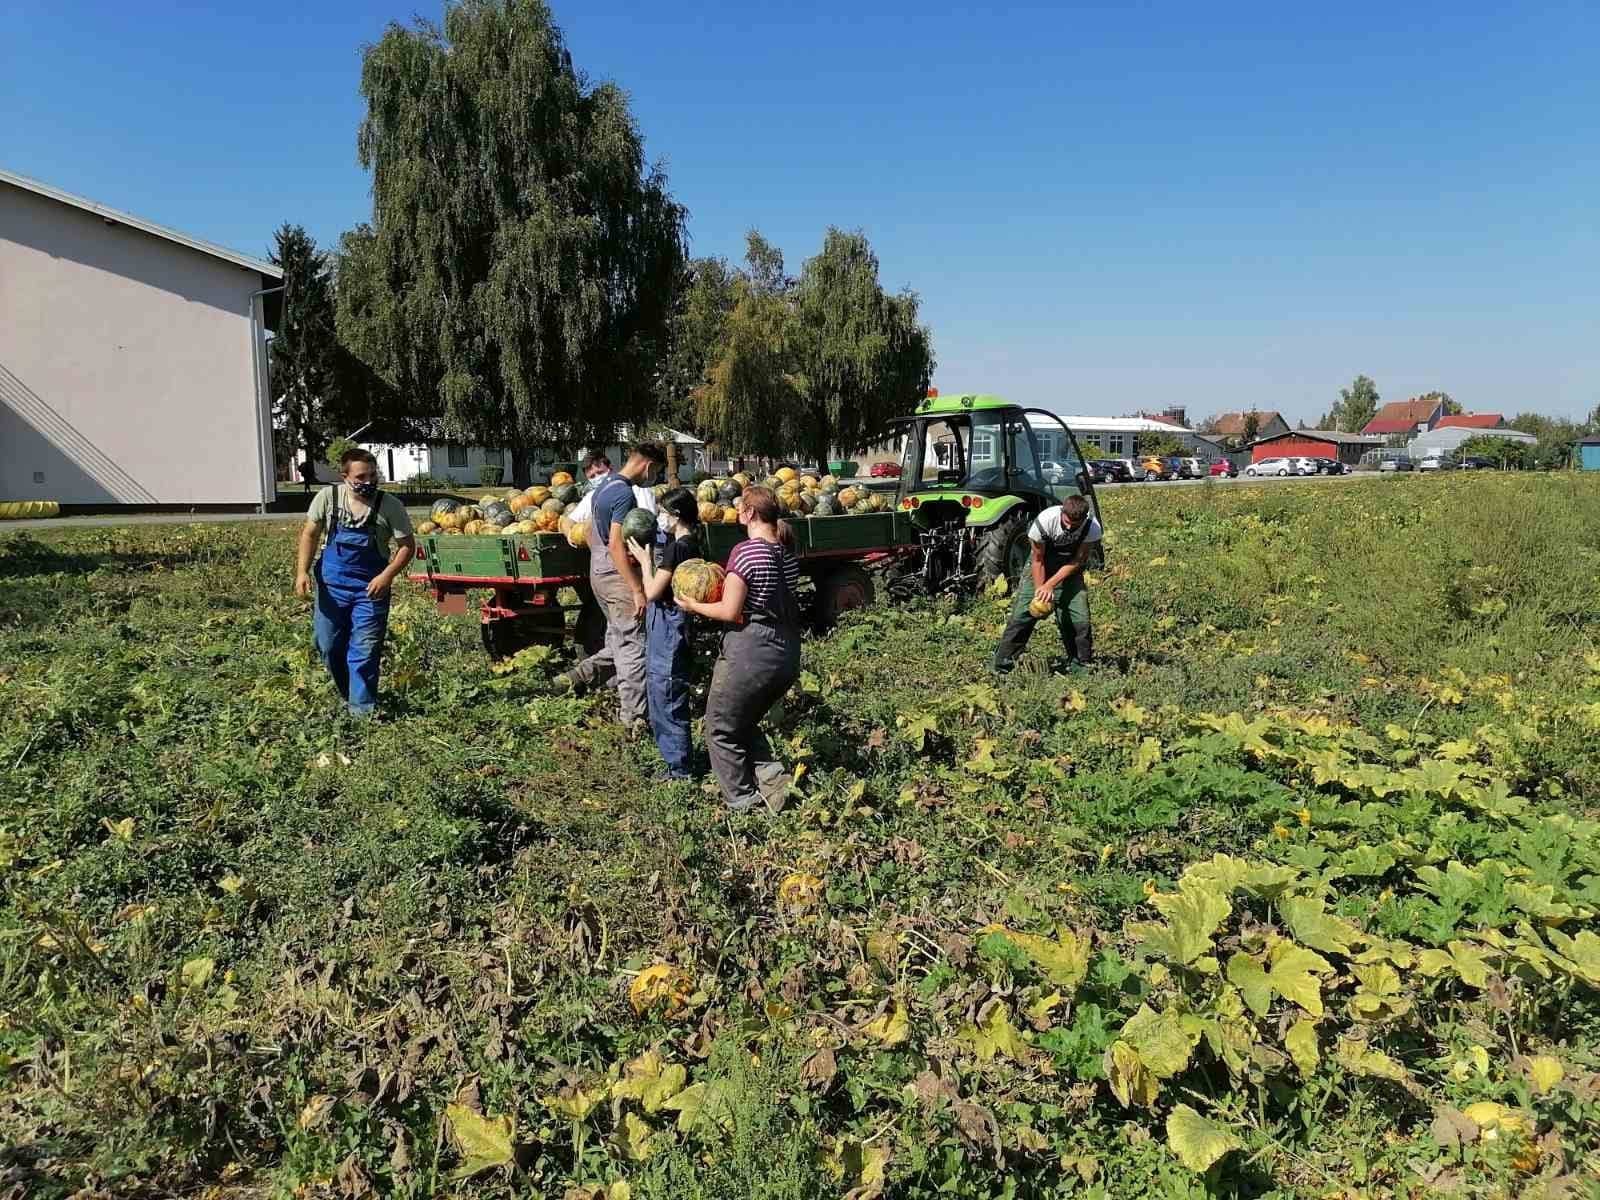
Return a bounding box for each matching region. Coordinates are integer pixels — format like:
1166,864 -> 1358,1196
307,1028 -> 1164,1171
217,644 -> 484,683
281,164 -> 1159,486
893,395 -> 1102,594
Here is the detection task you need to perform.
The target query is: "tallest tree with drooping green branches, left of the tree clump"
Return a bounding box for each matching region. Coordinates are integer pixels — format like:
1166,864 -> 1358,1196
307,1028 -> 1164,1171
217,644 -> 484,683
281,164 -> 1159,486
339,0 -> 685,477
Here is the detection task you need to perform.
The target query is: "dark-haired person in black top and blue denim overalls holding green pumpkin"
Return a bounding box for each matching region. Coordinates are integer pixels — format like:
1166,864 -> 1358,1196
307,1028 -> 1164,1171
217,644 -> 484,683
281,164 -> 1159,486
627,488 -> 701,781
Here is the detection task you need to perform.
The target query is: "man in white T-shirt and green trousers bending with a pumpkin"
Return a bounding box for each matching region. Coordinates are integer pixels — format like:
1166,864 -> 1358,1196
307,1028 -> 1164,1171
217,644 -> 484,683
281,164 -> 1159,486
994,496 -> 1102,674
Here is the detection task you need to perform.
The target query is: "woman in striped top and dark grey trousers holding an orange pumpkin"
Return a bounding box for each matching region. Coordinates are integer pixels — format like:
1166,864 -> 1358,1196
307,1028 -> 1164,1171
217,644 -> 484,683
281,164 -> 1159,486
678,488 -> 800,813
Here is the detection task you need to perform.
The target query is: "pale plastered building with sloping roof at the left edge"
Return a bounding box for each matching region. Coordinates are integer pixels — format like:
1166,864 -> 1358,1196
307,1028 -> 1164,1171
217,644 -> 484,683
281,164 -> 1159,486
0,182 -> 275,504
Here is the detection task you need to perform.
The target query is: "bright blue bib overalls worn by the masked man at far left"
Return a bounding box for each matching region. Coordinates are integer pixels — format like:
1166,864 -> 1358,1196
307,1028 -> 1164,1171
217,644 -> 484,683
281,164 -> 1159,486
312,485 -> 389,717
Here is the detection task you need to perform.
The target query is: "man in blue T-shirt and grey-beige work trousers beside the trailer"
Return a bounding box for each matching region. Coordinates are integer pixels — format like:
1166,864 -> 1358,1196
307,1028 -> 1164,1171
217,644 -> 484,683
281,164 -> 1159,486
558,443 -> 667,734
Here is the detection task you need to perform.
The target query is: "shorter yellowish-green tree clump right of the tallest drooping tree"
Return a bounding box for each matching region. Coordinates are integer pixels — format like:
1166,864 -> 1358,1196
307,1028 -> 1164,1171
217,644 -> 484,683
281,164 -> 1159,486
686,229 -> 933,462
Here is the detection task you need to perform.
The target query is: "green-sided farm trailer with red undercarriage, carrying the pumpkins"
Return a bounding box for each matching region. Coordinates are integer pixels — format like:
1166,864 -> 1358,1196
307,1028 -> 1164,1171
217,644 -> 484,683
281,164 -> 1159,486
411,510 -> 920,658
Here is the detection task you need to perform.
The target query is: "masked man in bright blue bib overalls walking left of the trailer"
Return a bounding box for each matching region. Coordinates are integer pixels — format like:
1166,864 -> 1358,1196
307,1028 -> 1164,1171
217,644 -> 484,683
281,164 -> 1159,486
294,448 -> 416,717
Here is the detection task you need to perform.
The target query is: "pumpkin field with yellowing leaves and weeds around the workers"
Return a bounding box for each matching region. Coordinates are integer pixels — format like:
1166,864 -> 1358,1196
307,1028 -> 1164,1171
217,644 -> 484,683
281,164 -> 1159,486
0,472 -> 1600,1200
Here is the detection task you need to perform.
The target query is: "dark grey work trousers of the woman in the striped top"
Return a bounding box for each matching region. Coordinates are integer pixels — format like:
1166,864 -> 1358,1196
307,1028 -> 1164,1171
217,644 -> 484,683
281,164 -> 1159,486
706,622 -> 800,810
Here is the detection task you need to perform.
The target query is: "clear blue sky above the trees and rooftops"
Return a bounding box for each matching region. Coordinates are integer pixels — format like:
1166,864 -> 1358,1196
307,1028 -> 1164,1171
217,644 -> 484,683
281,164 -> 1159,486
0,0 -> 1600,421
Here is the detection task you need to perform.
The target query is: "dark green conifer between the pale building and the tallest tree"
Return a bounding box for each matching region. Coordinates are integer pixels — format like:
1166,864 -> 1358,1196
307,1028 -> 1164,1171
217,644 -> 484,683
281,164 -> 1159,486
267,222 -> 418,473
